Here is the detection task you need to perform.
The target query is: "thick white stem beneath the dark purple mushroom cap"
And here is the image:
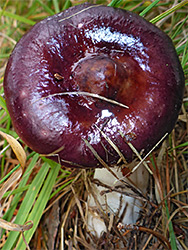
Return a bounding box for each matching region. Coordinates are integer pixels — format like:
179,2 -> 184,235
88,165 -> 149,237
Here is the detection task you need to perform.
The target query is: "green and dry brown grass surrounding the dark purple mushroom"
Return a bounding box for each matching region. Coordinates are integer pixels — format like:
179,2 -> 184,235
0,0 -> 188,249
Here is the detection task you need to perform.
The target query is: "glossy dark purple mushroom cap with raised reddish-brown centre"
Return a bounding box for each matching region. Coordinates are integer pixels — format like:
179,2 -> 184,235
4,3 -> 184,238
